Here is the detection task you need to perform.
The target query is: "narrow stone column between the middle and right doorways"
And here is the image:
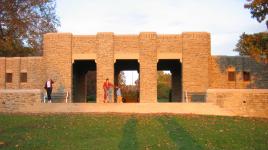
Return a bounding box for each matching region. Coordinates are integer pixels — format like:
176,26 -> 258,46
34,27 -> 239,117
139,32 -> 157,103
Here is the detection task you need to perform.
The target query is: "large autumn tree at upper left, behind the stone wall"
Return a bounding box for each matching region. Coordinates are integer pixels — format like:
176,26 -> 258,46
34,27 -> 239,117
0,0 -> 60,56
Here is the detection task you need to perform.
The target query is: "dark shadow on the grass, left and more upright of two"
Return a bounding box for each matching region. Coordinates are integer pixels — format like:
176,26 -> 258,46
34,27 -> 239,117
119,117 -> 138,150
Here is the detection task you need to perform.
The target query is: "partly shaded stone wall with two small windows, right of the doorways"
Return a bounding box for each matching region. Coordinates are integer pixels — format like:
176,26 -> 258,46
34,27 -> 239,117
209,56 -> 268,89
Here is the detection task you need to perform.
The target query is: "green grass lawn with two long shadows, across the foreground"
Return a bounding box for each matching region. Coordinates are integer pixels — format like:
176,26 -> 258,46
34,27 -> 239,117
0,114 -> 268,150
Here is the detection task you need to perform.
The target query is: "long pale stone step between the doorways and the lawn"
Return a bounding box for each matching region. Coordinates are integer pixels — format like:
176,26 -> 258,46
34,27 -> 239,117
18,103 -> 235,116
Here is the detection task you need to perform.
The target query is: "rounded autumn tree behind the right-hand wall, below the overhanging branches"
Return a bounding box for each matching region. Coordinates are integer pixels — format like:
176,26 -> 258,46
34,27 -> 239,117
235,32 -> 268,63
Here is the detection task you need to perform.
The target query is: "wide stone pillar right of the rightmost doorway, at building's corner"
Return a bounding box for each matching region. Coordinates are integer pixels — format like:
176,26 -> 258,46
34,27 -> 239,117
182,32 -> 210,97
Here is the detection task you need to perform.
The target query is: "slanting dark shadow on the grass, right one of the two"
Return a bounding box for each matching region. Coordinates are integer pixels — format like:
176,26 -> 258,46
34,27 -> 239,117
157,117 -> 203,150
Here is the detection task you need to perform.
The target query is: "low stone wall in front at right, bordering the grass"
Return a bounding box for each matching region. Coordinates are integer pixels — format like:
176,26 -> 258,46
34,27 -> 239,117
206,89 -> 268,118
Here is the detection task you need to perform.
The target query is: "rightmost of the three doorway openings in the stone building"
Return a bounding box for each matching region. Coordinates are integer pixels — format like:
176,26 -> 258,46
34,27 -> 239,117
157,59 -> 182,102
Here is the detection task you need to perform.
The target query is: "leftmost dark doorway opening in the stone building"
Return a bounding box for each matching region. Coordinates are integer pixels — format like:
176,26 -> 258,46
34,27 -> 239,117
73,60 -> 96,103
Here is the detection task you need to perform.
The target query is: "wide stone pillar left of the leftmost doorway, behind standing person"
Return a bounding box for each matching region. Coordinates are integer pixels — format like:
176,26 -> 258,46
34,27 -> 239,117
43,33 -> 72,101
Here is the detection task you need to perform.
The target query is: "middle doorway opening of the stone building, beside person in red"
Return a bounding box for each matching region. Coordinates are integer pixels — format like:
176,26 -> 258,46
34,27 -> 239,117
114,59 -> 140,103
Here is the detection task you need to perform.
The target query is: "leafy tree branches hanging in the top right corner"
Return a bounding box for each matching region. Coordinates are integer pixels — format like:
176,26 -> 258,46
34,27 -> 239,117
244,0 -> 268,28
